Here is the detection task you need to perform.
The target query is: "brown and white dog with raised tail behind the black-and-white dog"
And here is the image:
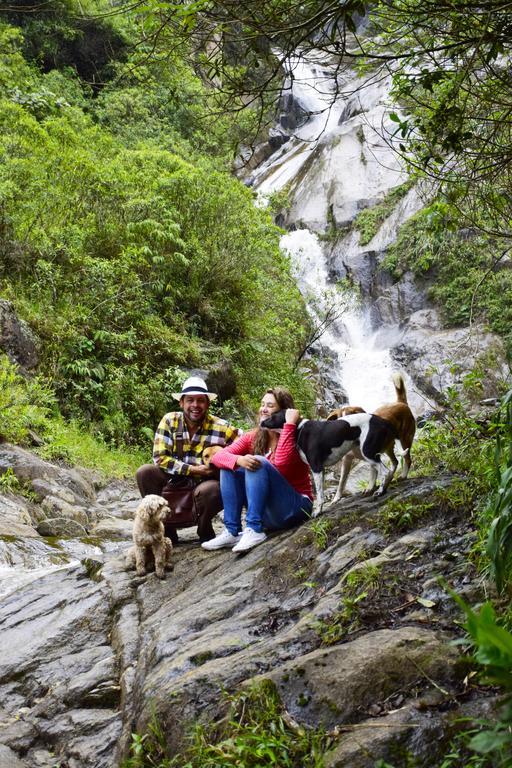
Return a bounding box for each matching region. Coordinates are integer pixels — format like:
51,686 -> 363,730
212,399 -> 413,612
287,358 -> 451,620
327,373 -> 416,506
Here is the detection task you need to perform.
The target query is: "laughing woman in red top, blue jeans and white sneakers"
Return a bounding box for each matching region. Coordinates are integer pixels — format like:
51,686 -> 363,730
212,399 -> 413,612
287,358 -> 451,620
201,388 -> 313,552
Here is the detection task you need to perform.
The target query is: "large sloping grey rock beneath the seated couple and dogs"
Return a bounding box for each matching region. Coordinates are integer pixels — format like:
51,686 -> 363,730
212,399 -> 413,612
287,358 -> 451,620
0,446 -> 492,768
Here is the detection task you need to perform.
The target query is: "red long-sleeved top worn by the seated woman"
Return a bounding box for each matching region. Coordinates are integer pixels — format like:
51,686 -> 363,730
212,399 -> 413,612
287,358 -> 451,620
212,424 -> 313,499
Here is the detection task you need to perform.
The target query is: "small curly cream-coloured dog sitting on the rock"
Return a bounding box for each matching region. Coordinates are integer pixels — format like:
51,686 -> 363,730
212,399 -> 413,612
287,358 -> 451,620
126,493 -> 172,579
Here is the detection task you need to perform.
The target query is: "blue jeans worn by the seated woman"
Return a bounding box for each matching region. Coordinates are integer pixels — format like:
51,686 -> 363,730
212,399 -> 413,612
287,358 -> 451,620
220,456 -> 313,536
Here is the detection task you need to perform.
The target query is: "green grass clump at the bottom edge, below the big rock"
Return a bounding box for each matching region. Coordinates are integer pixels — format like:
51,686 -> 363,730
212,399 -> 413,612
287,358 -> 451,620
123,680 -> 328,768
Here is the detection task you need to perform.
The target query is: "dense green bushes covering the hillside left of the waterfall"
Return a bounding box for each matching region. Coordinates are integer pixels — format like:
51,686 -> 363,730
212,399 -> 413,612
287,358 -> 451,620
0,0 -> 310,456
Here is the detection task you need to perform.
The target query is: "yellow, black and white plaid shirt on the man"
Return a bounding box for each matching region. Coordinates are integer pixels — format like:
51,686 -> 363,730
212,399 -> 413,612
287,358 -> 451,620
153,411 -> 242,475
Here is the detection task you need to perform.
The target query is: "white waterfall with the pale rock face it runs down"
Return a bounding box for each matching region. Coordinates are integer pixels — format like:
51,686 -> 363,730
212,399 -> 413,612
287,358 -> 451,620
248,53 -> 423,412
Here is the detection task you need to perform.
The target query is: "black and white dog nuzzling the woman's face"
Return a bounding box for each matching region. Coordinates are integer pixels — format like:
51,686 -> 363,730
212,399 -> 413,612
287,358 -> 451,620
260,411 -> 396,517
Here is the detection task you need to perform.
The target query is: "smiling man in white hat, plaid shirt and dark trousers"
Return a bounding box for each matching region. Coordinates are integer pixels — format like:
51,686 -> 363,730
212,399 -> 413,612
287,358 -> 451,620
136,376 -> 240,544
